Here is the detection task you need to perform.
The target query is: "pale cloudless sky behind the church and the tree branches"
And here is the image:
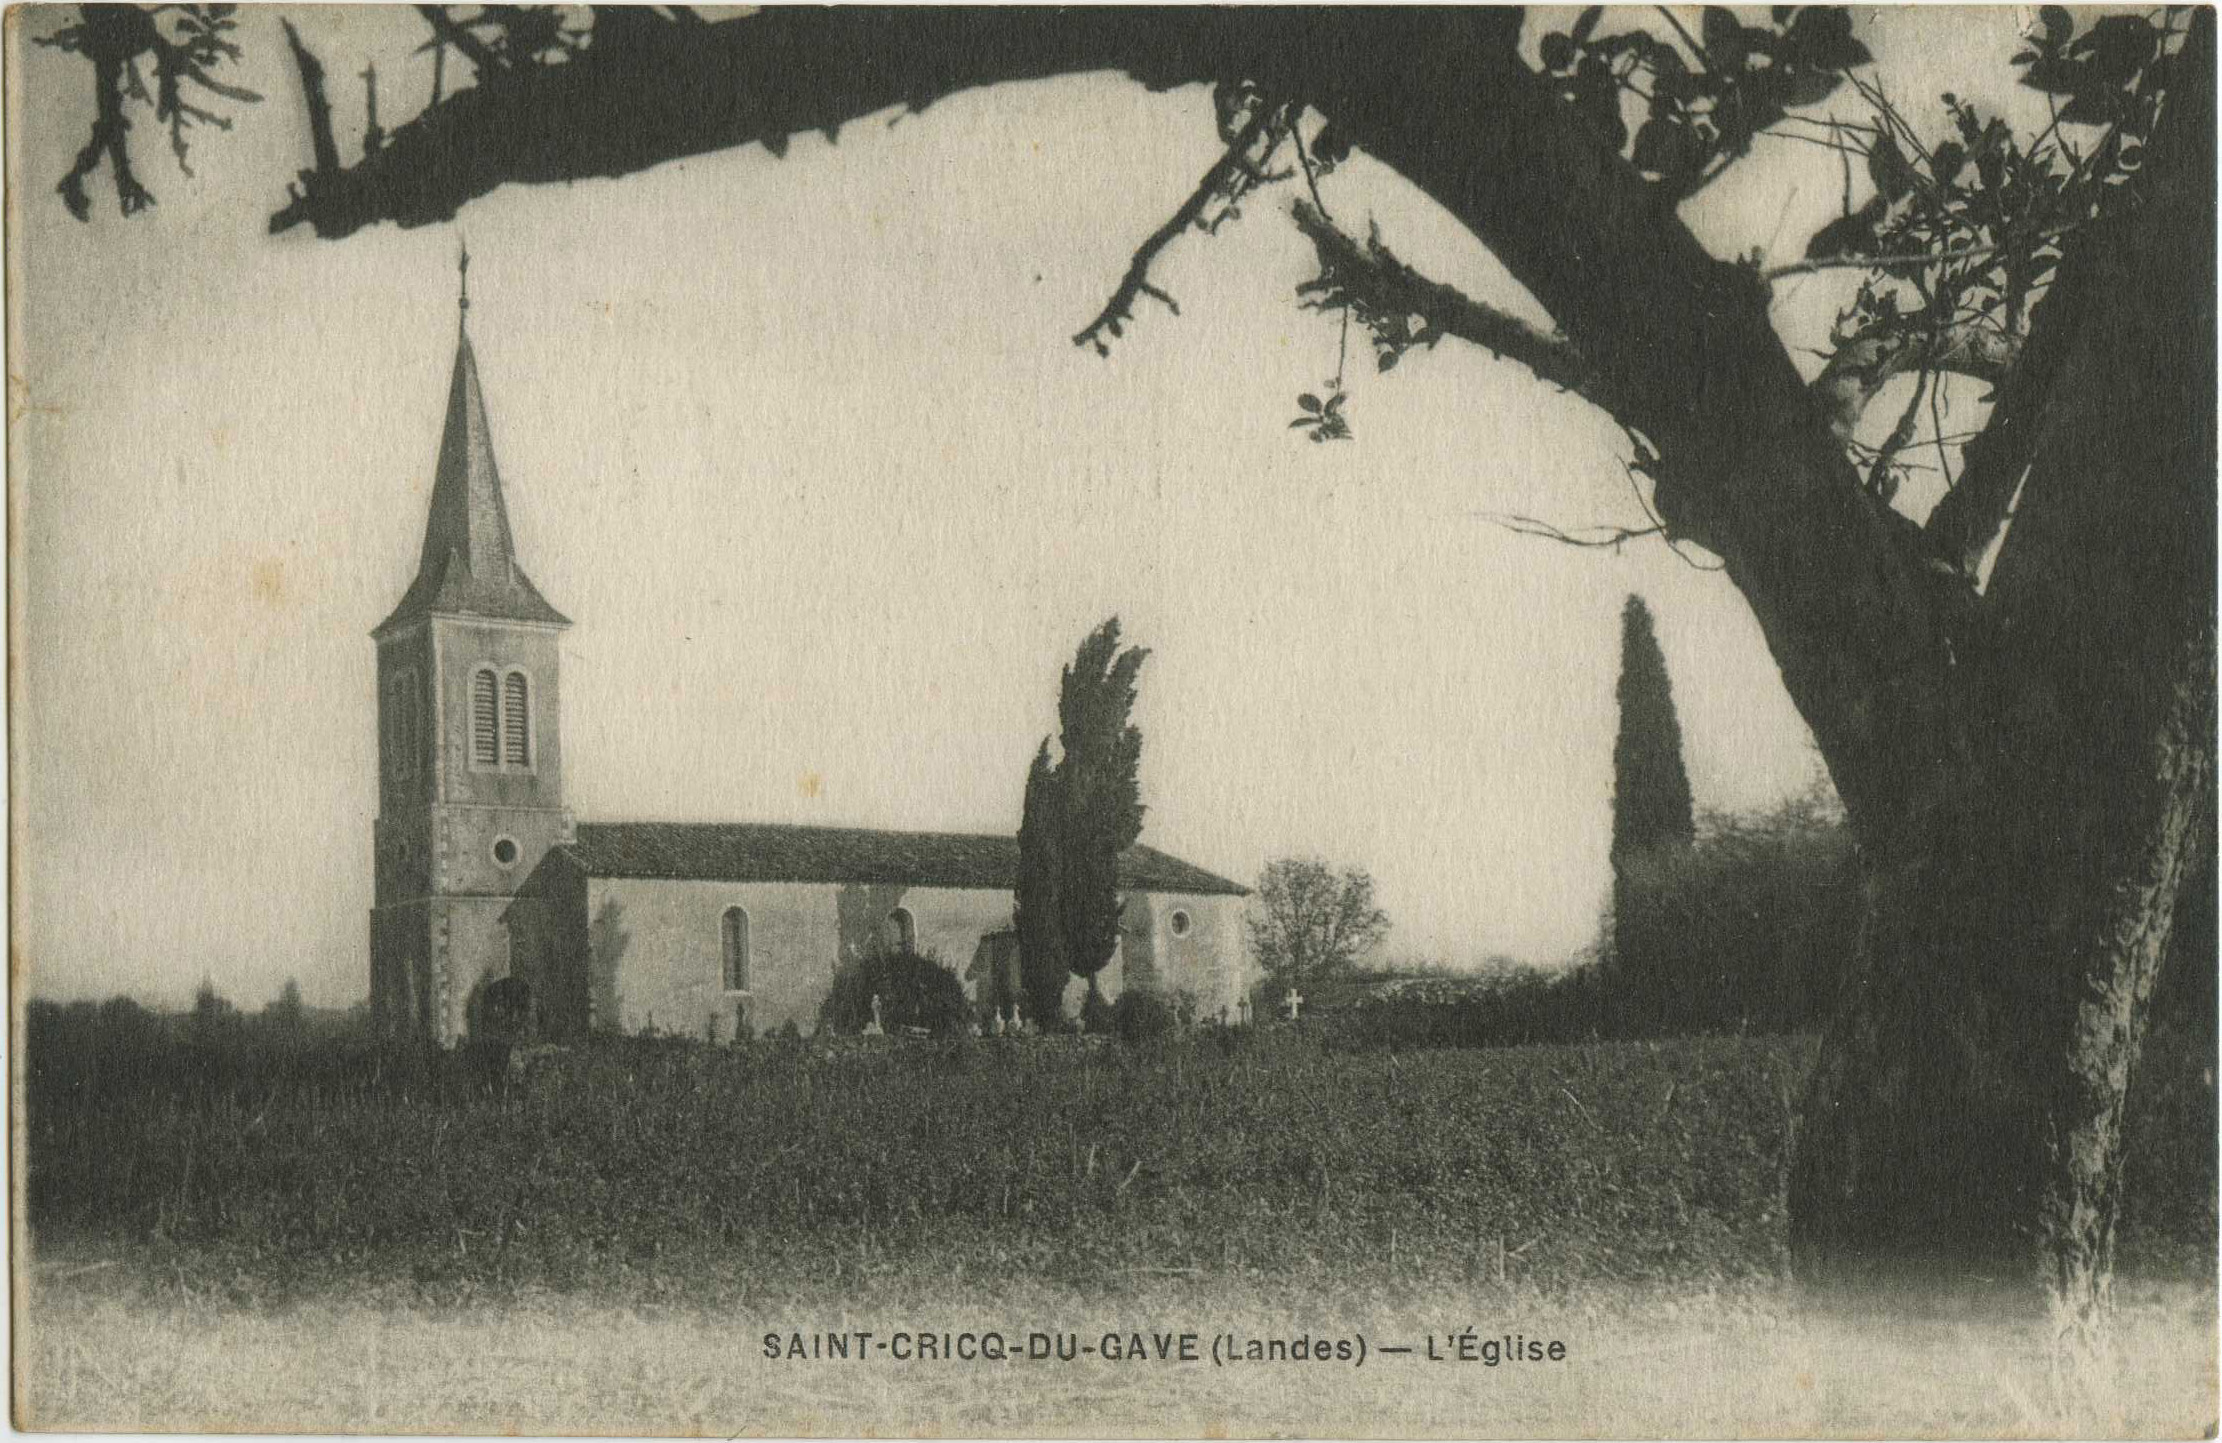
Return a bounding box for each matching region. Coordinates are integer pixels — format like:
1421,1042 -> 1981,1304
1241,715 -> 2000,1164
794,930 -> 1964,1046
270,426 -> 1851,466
9,7 -> 2042,1005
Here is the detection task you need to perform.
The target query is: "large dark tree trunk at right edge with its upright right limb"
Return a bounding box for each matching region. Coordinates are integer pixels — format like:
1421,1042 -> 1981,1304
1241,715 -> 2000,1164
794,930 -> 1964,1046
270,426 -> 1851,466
1789,20 -> 2215,1316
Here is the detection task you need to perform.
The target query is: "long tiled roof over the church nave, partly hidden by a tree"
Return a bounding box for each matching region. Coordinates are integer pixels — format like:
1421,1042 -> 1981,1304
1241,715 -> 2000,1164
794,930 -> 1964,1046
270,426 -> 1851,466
564,823 -> 1249,896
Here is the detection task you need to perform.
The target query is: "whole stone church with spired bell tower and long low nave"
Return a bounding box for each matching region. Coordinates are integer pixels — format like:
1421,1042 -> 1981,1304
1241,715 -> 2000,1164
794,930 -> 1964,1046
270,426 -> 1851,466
371,258 -> 1251,1045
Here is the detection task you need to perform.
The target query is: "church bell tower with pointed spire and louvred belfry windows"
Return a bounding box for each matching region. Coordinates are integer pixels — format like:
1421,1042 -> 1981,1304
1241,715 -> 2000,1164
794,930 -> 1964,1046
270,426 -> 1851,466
371,251 -> 571,1045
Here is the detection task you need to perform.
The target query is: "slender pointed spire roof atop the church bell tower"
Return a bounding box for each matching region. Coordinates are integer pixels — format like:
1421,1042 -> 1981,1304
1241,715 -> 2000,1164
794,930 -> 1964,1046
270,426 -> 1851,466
373,249 -> 569,636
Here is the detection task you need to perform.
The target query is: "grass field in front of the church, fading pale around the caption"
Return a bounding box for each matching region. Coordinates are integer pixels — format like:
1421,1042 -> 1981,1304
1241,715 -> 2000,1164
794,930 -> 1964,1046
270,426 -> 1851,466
18,1029 -> 2215,1434
